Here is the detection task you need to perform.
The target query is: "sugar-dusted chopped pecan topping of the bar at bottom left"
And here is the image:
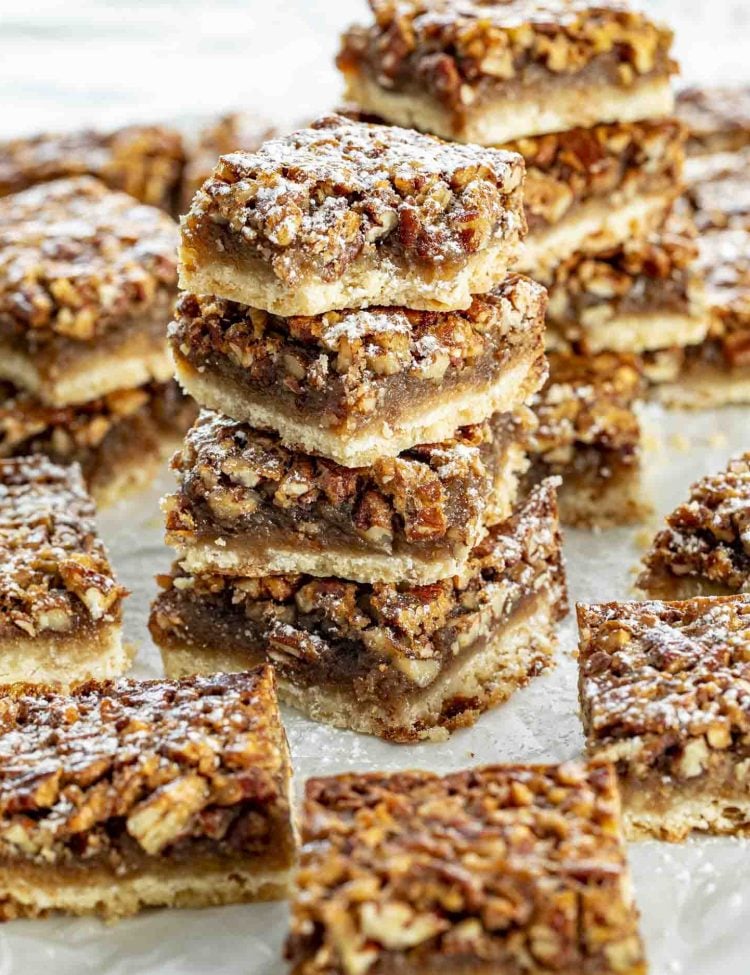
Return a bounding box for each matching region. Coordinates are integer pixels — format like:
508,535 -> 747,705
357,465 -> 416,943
0,668 -> 289,873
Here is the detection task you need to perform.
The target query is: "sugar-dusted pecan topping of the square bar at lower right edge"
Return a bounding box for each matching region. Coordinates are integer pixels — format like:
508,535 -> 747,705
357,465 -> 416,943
578,596 -> 750,780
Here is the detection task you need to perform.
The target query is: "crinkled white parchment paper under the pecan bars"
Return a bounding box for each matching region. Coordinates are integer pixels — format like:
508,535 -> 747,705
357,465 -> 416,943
0,406 -> 750,975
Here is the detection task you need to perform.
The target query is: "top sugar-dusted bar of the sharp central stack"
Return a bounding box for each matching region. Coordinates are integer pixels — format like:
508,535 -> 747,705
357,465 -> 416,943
180,115 -> 526,315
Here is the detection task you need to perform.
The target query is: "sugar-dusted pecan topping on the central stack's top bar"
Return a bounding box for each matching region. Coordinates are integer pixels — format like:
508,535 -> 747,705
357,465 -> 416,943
182,116 -> 524,287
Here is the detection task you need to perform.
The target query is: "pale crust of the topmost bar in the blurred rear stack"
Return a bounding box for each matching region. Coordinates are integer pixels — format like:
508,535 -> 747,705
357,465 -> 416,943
346,74 -> 674,146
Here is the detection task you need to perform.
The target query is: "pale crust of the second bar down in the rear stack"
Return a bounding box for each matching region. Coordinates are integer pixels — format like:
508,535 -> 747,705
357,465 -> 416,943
515,192 -> 673,283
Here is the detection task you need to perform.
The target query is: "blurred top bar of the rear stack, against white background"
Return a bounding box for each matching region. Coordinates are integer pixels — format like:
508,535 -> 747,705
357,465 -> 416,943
338,0 -> 676,145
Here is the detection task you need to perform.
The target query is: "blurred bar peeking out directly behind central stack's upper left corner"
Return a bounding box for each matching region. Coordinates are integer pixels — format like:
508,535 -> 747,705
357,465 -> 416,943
180,112 -> 277,213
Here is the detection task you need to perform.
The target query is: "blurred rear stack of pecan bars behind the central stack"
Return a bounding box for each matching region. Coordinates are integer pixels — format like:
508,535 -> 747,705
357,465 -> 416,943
338,0 -> 708,525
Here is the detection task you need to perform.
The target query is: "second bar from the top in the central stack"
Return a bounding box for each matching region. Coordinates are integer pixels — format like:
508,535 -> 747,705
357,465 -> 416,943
170,275 -> 547,467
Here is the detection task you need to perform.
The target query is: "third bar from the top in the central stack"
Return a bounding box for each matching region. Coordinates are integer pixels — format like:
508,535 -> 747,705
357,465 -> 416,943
163,410 -> 533,584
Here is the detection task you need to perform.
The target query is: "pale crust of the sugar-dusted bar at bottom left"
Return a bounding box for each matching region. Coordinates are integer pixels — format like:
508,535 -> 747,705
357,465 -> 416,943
0,861 -> 291,920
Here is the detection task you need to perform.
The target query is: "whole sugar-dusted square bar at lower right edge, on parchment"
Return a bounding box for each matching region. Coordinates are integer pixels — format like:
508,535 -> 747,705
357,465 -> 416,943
578,596 -> 750,841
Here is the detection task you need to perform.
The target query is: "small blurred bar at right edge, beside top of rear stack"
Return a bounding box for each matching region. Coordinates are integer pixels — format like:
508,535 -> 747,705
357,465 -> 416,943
677,86 -> 750,156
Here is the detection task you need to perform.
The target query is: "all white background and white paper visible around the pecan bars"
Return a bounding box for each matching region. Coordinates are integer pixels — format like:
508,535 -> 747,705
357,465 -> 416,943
0,0 -> 750,975
